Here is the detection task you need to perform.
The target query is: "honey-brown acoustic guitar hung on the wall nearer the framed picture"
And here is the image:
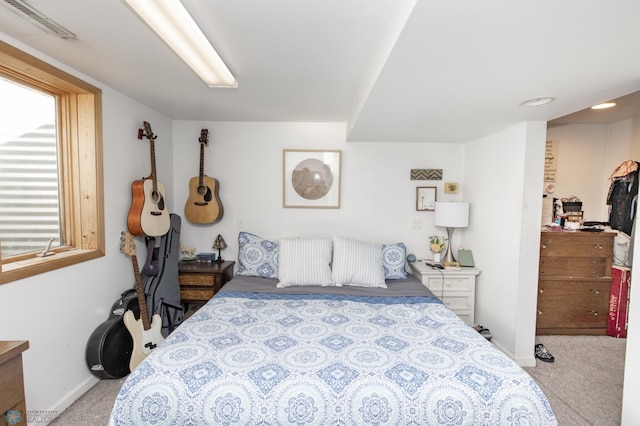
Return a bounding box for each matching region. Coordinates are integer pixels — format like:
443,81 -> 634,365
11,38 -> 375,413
184,129 -> 224,224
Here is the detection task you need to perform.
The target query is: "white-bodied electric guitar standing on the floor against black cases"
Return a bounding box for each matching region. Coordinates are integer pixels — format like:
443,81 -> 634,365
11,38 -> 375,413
120,232 -> 164,371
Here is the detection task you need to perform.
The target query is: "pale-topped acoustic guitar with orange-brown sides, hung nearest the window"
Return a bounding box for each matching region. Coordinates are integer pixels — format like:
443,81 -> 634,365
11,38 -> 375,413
127,121 -> 171,237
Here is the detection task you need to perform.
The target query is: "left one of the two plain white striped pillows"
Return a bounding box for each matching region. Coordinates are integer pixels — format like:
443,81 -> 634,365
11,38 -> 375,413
276,238 -> 333,288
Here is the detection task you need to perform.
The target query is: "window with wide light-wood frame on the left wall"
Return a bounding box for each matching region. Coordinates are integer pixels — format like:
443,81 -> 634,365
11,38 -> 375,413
0,41 -> 104,284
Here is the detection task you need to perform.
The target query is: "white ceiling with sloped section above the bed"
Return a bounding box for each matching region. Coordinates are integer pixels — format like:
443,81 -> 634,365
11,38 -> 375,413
0,0 -> 640,143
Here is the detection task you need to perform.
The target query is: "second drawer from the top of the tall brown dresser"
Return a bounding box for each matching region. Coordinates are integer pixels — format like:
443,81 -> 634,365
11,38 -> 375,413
539,257 -> 611,280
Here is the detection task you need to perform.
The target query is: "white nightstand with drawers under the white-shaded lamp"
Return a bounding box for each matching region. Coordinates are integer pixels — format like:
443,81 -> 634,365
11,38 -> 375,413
409,261 -> 480,325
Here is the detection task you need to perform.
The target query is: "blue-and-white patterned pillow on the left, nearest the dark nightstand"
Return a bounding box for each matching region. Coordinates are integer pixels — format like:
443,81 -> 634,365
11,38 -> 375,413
236,232 -> 279,278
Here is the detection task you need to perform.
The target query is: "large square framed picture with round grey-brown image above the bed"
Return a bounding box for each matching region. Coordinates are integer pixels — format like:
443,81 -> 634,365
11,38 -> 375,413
282,149 -> 342,209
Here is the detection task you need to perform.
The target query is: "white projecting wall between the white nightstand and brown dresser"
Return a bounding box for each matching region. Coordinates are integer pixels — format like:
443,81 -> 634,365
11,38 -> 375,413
464,122 -> 546,366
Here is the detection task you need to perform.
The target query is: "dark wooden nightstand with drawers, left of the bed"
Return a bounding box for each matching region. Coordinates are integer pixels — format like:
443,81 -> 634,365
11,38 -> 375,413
178,261 -> 235,305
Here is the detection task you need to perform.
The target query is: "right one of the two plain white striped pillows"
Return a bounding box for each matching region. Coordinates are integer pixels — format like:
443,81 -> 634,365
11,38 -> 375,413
331,235 -> 387,288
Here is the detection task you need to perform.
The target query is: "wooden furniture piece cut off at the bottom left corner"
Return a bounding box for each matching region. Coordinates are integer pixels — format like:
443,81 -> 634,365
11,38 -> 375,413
0,340 -> 29,425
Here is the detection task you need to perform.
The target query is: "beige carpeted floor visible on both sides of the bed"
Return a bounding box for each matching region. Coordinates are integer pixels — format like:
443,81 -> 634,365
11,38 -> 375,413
53,336 -> 626,426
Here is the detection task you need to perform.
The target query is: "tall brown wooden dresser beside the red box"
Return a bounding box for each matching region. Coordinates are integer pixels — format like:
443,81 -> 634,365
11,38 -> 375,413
536,231 -> 616,335
